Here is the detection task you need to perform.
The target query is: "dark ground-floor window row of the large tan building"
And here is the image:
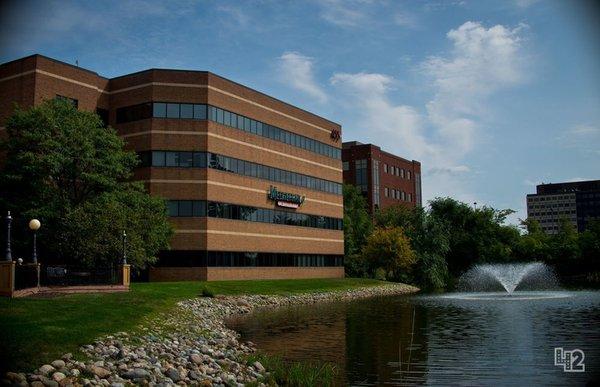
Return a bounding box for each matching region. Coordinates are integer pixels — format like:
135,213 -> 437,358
157,250 -> 344,267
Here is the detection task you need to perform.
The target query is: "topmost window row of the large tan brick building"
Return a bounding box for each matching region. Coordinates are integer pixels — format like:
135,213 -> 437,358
117,102 -> 342,159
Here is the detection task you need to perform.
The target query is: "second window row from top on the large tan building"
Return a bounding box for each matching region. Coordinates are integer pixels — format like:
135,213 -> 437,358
139,151 -> 342,195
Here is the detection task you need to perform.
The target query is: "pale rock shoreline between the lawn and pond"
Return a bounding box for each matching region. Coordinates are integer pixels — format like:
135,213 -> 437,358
2,284 -> 418,387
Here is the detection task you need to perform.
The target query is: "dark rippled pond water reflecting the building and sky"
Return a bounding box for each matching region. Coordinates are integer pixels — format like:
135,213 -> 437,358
230,292 -> 600,386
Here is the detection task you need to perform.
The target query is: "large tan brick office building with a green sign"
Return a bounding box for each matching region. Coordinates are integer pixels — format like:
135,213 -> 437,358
0,55 -> 344,280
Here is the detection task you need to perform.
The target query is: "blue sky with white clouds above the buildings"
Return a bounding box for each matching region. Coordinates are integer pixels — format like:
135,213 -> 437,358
0,0 -> 600,222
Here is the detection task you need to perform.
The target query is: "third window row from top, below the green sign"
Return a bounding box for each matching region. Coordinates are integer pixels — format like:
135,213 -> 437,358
167,200 -> 343,230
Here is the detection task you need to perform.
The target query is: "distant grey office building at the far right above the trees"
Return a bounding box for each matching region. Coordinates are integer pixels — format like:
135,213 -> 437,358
527,180 -> 600,234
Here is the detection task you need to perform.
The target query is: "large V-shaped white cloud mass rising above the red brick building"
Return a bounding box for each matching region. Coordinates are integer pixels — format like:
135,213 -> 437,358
330,22 -> 524,202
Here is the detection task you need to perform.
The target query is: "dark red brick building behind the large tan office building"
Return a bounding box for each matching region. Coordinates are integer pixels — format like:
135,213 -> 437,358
342,141 -> 421,213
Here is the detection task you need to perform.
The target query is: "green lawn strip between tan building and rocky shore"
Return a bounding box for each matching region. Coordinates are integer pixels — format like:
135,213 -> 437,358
0,278 -> 381,372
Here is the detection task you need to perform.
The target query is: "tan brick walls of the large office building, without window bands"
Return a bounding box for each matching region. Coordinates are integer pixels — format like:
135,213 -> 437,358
0,55 -> 344,280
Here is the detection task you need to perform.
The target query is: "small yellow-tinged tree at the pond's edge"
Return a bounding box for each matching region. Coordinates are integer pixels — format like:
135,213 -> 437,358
363,227 -> 416,282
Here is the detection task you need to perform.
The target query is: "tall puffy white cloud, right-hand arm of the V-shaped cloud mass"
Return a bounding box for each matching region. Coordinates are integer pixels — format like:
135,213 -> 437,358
421,22 -> 523,156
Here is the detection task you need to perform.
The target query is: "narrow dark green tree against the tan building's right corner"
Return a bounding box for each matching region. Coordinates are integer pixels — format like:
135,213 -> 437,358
343,184 -> 373,277
